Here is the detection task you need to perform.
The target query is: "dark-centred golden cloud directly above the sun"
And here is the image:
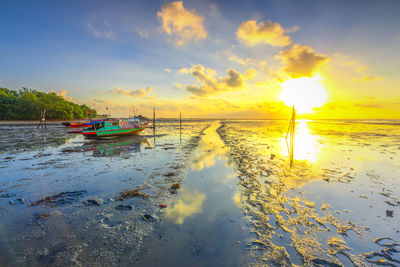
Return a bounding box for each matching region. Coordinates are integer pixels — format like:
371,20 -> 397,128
277,44 -> 330,78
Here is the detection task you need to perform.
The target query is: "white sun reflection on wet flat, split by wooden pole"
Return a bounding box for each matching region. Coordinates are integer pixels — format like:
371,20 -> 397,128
281,120 -> 320,163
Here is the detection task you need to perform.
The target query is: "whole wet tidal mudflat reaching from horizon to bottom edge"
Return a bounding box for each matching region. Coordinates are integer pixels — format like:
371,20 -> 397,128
0,120 -> 400,266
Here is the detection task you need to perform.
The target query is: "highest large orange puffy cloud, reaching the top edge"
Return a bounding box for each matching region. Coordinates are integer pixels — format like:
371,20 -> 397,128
157,1 -> 207,45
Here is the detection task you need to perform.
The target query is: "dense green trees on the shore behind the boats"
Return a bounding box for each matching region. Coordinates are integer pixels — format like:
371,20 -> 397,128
0,88 -> 97,120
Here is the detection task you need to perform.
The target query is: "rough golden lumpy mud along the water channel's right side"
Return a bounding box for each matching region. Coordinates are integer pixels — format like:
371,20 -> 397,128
217,122 -> 361,266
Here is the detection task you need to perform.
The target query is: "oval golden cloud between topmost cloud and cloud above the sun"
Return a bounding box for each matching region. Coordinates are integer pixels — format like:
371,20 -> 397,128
236,20 -> 292,46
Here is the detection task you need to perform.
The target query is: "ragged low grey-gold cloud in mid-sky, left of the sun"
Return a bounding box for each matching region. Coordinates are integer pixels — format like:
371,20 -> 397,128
185,64 -> 256,96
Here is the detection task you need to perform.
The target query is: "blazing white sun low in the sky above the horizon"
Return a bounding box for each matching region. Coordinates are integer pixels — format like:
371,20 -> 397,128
279,76 -> 327,113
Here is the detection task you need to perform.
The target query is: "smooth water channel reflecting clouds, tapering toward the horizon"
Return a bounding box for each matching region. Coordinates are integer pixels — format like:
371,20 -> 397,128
137,123 -> 251,266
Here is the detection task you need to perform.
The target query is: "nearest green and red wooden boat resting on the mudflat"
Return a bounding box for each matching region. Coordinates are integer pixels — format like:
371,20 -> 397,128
68,119 -> 150,138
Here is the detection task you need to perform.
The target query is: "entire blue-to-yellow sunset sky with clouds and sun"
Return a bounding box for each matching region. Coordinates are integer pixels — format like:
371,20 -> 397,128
0,0 -> 400,119
